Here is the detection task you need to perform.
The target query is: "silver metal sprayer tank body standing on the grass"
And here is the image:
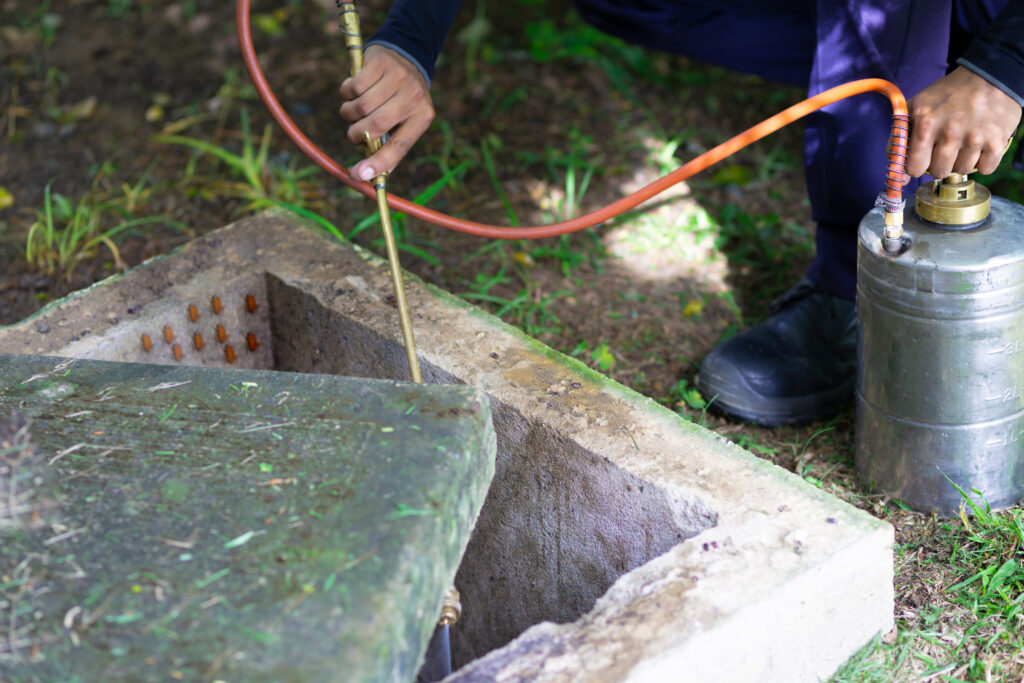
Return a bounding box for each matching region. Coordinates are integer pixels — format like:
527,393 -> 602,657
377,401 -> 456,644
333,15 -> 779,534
856,198 -> 1024,515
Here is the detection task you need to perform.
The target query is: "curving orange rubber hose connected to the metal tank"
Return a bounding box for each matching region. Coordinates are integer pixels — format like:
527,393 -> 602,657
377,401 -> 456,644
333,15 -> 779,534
236,0 -> 908,240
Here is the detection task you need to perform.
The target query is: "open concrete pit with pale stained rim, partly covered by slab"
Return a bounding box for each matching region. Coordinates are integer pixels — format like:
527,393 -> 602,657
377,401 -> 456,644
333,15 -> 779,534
0,215 -> 893,683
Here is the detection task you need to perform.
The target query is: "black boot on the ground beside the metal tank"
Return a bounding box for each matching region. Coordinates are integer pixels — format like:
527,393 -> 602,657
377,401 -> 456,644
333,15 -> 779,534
697,279 -> 857,426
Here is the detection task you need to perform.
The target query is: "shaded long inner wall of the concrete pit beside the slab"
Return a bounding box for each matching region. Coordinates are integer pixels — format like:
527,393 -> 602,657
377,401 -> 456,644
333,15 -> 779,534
266,274 -> 717,667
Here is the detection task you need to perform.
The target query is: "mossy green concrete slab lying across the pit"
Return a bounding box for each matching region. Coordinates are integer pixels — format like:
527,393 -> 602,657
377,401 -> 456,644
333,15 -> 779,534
0,355 -> 496,681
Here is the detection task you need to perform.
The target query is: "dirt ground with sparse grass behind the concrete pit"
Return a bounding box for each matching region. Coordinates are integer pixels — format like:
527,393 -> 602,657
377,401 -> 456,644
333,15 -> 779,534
6,0 -> 1024,680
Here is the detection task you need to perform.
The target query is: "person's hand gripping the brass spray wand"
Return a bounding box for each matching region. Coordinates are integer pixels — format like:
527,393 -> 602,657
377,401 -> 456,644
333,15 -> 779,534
341,45 -> 434,180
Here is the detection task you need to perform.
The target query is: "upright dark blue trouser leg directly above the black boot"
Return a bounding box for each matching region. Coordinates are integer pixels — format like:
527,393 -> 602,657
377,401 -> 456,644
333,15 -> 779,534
805,0 -> 950,299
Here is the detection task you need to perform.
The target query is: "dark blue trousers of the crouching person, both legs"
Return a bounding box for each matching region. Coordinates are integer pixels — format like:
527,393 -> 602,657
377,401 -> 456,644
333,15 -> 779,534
574,0 -> 1007,299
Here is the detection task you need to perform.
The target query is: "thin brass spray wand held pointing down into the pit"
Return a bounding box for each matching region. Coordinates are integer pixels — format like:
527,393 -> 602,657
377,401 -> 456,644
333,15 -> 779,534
337,0 -> 423,383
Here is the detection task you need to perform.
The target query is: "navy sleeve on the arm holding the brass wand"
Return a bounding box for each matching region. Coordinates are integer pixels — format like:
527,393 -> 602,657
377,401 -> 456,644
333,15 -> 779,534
367,0 -> 462,85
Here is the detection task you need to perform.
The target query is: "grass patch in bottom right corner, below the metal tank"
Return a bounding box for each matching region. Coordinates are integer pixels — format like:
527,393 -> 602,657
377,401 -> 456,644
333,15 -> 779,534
833,492 -> 1024,683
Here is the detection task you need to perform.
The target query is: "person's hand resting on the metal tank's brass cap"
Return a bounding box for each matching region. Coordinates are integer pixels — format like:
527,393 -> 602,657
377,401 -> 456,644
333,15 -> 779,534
906,67 -> 1021,178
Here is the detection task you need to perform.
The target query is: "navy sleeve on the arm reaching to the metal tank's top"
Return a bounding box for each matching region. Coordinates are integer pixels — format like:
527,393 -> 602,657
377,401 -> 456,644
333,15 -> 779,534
957,0 -> 1024,106
